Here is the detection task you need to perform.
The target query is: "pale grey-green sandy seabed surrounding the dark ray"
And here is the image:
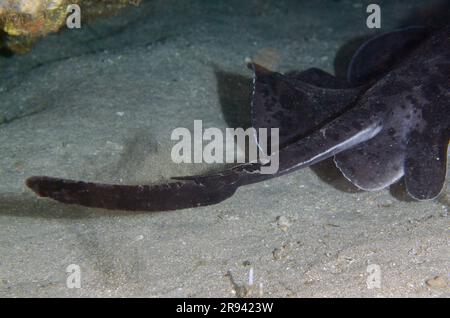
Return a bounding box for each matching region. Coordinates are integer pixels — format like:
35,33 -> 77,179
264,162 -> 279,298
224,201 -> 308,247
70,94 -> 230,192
0,0 -> 450,297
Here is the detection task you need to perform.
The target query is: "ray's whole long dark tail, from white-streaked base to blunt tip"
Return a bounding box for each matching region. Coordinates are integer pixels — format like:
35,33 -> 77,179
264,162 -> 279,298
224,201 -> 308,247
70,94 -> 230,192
26,107 -> 381,211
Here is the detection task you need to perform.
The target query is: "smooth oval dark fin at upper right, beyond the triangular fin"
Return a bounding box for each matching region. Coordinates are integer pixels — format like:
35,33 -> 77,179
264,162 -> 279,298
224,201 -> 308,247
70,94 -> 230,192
347,26 -> 429,85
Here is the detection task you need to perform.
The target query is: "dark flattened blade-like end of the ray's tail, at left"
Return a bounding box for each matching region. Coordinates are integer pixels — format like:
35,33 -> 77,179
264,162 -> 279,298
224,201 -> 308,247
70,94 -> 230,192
26,176 -> 237,211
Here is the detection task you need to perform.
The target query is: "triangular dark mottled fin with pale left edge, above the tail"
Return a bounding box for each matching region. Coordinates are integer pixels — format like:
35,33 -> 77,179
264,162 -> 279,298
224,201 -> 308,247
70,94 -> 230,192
249,64 -> 360,147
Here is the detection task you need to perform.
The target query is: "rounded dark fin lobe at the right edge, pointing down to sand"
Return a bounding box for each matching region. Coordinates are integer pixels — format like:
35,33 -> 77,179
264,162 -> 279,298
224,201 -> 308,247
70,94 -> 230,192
405,135 -> 448,200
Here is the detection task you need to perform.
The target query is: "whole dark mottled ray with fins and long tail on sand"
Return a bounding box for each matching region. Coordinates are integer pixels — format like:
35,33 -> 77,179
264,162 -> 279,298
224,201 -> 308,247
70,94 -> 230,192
27,26 -> 450,211
